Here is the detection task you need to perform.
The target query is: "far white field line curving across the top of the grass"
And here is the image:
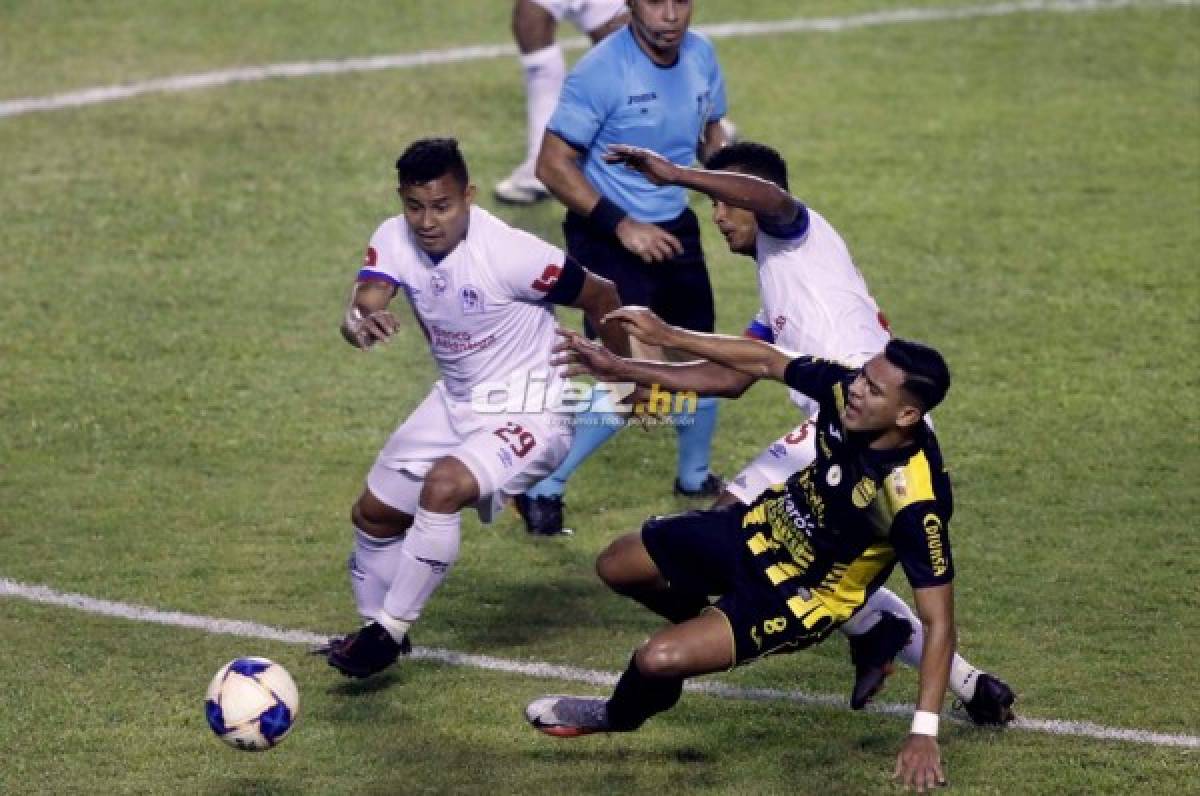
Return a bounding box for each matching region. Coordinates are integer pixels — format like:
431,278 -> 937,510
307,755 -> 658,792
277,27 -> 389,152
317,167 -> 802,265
0,0 -> 1200,118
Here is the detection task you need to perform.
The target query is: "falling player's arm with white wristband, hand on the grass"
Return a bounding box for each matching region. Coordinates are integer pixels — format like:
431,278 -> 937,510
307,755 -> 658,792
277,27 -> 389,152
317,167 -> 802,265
893,583 -> 955,794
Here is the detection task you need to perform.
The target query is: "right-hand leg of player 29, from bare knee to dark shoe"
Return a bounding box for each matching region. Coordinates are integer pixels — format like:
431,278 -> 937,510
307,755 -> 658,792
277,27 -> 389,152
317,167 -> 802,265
328,456 -> 479,677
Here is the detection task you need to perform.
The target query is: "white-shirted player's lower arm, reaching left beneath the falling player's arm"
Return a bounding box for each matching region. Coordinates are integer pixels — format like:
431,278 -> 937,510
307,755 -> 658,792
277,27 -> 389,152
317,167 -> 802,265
553,329 -> 755,399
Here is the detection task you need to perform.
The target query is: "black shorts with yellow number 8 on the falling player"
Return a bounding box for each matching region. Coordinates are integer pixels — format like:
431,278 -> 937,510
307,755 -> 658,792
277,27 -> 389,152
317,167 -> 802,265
642,505 -> 836,664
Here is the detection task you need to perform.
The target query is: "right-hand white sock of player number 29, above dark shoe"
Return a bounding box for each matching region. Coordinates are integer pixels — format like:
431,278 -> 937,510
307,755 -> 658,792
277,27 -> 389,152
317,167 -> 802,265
376,508 -> 462,641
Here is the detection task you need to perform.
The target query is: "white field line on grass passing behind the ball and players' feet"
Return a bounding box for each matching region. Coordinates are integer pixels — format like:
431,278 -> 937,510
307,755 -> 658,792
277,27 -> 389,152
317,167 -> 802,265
0,577 -> 1200,749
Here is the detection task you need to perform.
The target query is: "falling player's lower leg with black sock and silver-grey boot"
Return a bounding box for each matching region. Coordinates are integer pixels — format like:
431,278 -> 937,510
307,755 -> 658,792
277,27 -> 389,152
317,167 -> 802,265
526,610 -> 733,737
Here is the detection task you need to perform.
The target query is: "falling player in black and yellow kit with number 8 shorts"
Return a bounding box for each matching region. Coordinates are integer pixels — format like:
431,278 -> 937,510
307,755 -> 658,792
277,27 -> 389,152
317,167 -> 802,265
527,307 -> 955,788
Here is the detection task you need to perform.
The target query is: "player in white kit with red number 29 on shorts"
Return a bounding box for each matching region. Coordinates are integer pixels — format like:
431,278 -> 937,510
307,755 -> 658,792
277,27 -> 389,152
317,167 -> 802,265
322,138 -> 628,677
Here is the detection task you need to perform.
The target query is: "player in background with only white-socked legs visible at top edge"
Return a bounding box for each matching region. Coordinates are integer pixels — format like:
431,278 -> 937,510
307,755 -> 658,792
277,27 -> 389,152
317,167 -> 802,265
496,0 -> 629,204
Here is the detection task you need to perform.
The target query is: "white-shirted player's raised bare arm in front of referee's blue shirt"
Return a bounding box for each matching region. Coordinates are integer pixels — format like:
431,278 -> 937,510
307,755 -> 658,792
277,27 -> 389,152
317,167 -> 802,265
605,144 -> 800,226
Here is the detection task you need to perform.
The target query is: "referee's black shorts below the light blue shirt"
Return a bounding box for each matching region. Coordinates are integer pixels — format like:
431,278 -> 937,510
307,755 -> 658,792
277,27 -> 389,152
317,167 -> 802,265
563,208 -> 716,337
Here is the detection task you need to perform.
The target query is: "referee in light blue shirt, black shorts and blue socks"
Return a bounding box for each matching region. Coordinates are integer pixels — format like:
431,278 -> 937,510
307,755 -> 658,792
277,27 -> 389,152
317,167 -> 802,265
516,0 -> 727,535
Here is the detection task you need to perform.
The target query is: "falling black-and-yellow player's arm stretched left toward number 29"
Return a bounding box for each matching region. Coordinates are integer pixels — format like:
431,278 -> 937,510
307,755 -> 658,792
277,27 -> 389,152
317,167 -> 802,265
605,306 -> 794,382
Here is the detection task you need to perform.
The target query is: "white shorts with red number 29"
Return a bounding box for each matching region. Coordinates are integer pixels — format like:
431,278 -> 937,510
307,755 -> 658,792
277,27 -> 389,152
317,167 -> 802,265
367,381 -> 572,522
